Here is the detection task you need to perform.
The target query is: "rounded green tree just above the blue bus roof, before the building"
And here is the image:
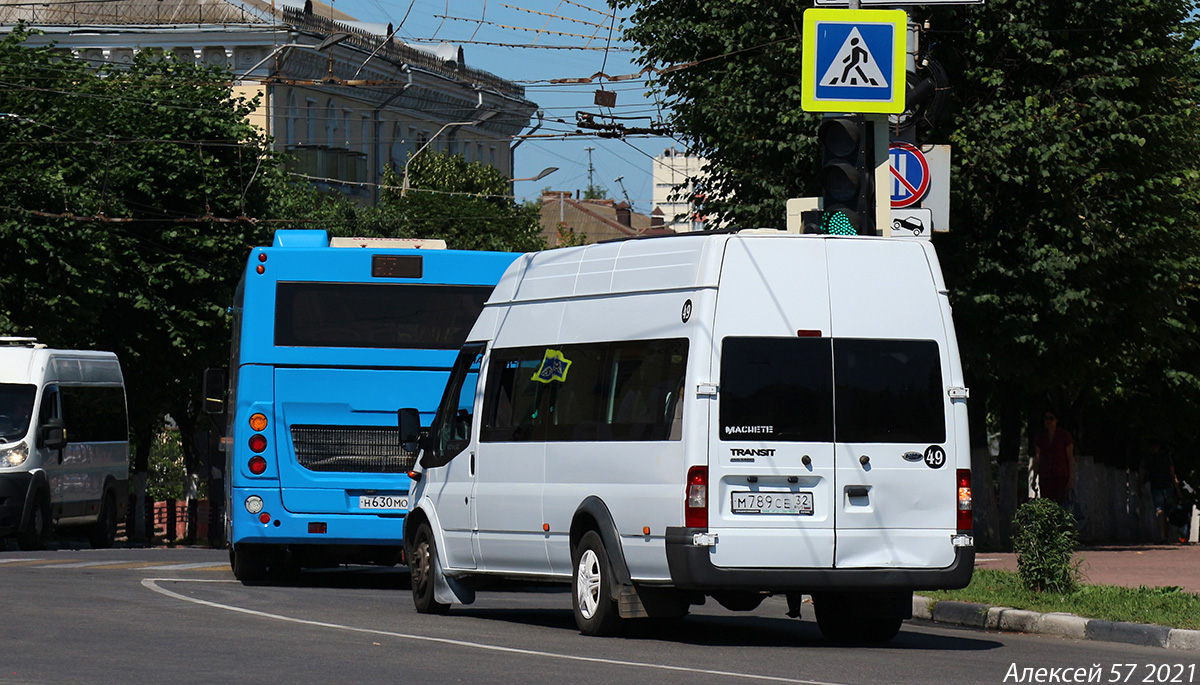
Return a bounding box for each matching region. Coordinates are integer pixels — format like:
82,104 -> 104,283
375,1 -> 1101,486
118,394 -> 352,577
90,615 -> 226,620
369,152 -> 546,252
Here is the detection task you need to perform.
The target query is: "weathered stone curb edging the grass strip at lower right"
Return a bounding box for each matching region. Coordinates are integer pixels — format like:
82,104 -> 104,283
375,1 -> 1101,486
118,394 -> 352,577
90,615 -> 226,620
912,595 -> 1200,651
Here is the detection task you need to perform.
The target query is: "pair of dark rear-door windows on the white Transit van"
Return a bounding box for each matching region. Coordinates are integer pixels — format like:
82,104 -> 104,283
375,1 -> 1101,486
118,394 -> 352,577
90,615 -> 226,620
720,337 -> 946,444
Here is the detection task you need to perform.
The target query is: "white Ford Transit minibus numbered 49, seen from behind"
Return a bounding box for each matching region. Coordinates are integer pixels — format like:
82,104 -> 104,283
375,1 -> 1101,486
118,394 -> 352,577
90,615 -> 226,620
400,230 -> 974,641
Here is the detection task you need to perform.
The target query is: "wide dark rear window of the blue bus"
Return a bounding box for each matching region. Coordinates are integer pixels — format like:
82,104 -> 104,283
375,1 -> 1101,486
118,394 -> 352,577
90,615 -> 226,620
275,282 -> 492,350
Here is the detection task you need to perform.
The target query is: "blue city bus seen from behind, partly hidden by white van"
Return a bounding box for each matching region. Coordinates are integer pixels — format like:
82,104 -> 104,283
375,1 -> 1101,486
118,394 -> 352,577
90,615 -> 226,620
218,230 -> 517,581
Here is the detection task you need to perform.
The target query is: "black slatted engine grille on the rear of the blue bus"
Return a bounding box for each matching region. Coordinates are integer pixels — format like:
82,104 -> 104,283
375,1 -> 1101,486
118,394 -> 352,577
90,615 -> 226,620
292,426 -> 415,474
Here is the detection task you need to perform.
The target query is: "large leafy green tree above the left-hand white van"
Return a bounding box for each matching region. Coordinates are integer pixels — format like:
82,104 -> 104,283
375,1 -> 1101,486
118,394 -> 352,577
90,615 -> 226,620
0,26 -> 278,539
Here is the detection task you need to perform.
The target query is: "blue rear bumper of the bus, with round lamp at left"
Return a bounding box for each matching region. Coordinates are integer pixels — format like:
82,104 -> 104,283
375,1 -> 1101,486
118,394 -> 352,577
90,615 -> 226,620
228,487 -> 407,546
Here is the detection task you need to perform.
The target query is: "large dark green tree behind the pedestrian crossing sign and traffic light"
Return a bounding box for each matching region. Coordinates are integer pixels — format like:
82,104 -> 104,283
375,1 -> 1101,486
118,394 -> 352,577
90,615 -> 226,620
619,0 -> 1200,547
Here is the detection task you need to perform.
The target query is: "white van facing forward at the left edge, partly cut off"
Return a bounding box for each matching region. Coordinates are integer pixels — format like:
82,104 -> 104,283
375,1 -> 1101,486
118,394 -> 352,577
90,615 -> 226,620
0,337 -> 130,549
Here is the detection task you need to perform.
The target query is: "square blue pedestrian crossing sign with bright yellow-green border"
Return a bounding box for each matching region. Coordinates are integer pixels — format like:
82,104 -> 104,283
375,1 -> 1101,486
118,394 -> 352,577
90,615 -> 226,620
800,8 -> 908,114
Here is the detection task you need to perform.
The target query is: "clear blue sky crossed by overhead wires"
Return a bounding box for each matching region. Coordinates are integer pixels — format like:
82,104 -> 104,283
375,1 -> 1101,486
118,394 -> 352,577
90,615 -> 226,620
326,0 -> 683,208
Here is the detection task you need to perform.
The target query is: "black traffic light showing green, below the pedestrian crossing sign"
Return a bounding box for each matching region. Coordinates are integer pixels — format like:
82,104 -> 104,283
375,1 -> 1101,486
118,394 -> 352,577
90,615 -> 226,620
804,114 -> 875,235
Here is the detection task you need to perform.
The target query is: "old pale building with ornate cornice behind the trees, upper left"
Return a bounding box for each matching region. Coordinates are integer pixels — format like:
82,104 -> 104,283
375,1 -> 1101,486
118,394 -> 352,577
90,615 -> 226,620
0,0 -> 536,203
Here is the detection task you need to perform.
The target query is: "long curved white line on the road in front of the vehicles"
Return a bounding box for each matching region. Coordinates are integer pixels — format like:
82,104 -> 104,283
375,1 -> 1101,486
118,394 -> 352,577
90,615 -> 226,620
142,578 -> 836,685
